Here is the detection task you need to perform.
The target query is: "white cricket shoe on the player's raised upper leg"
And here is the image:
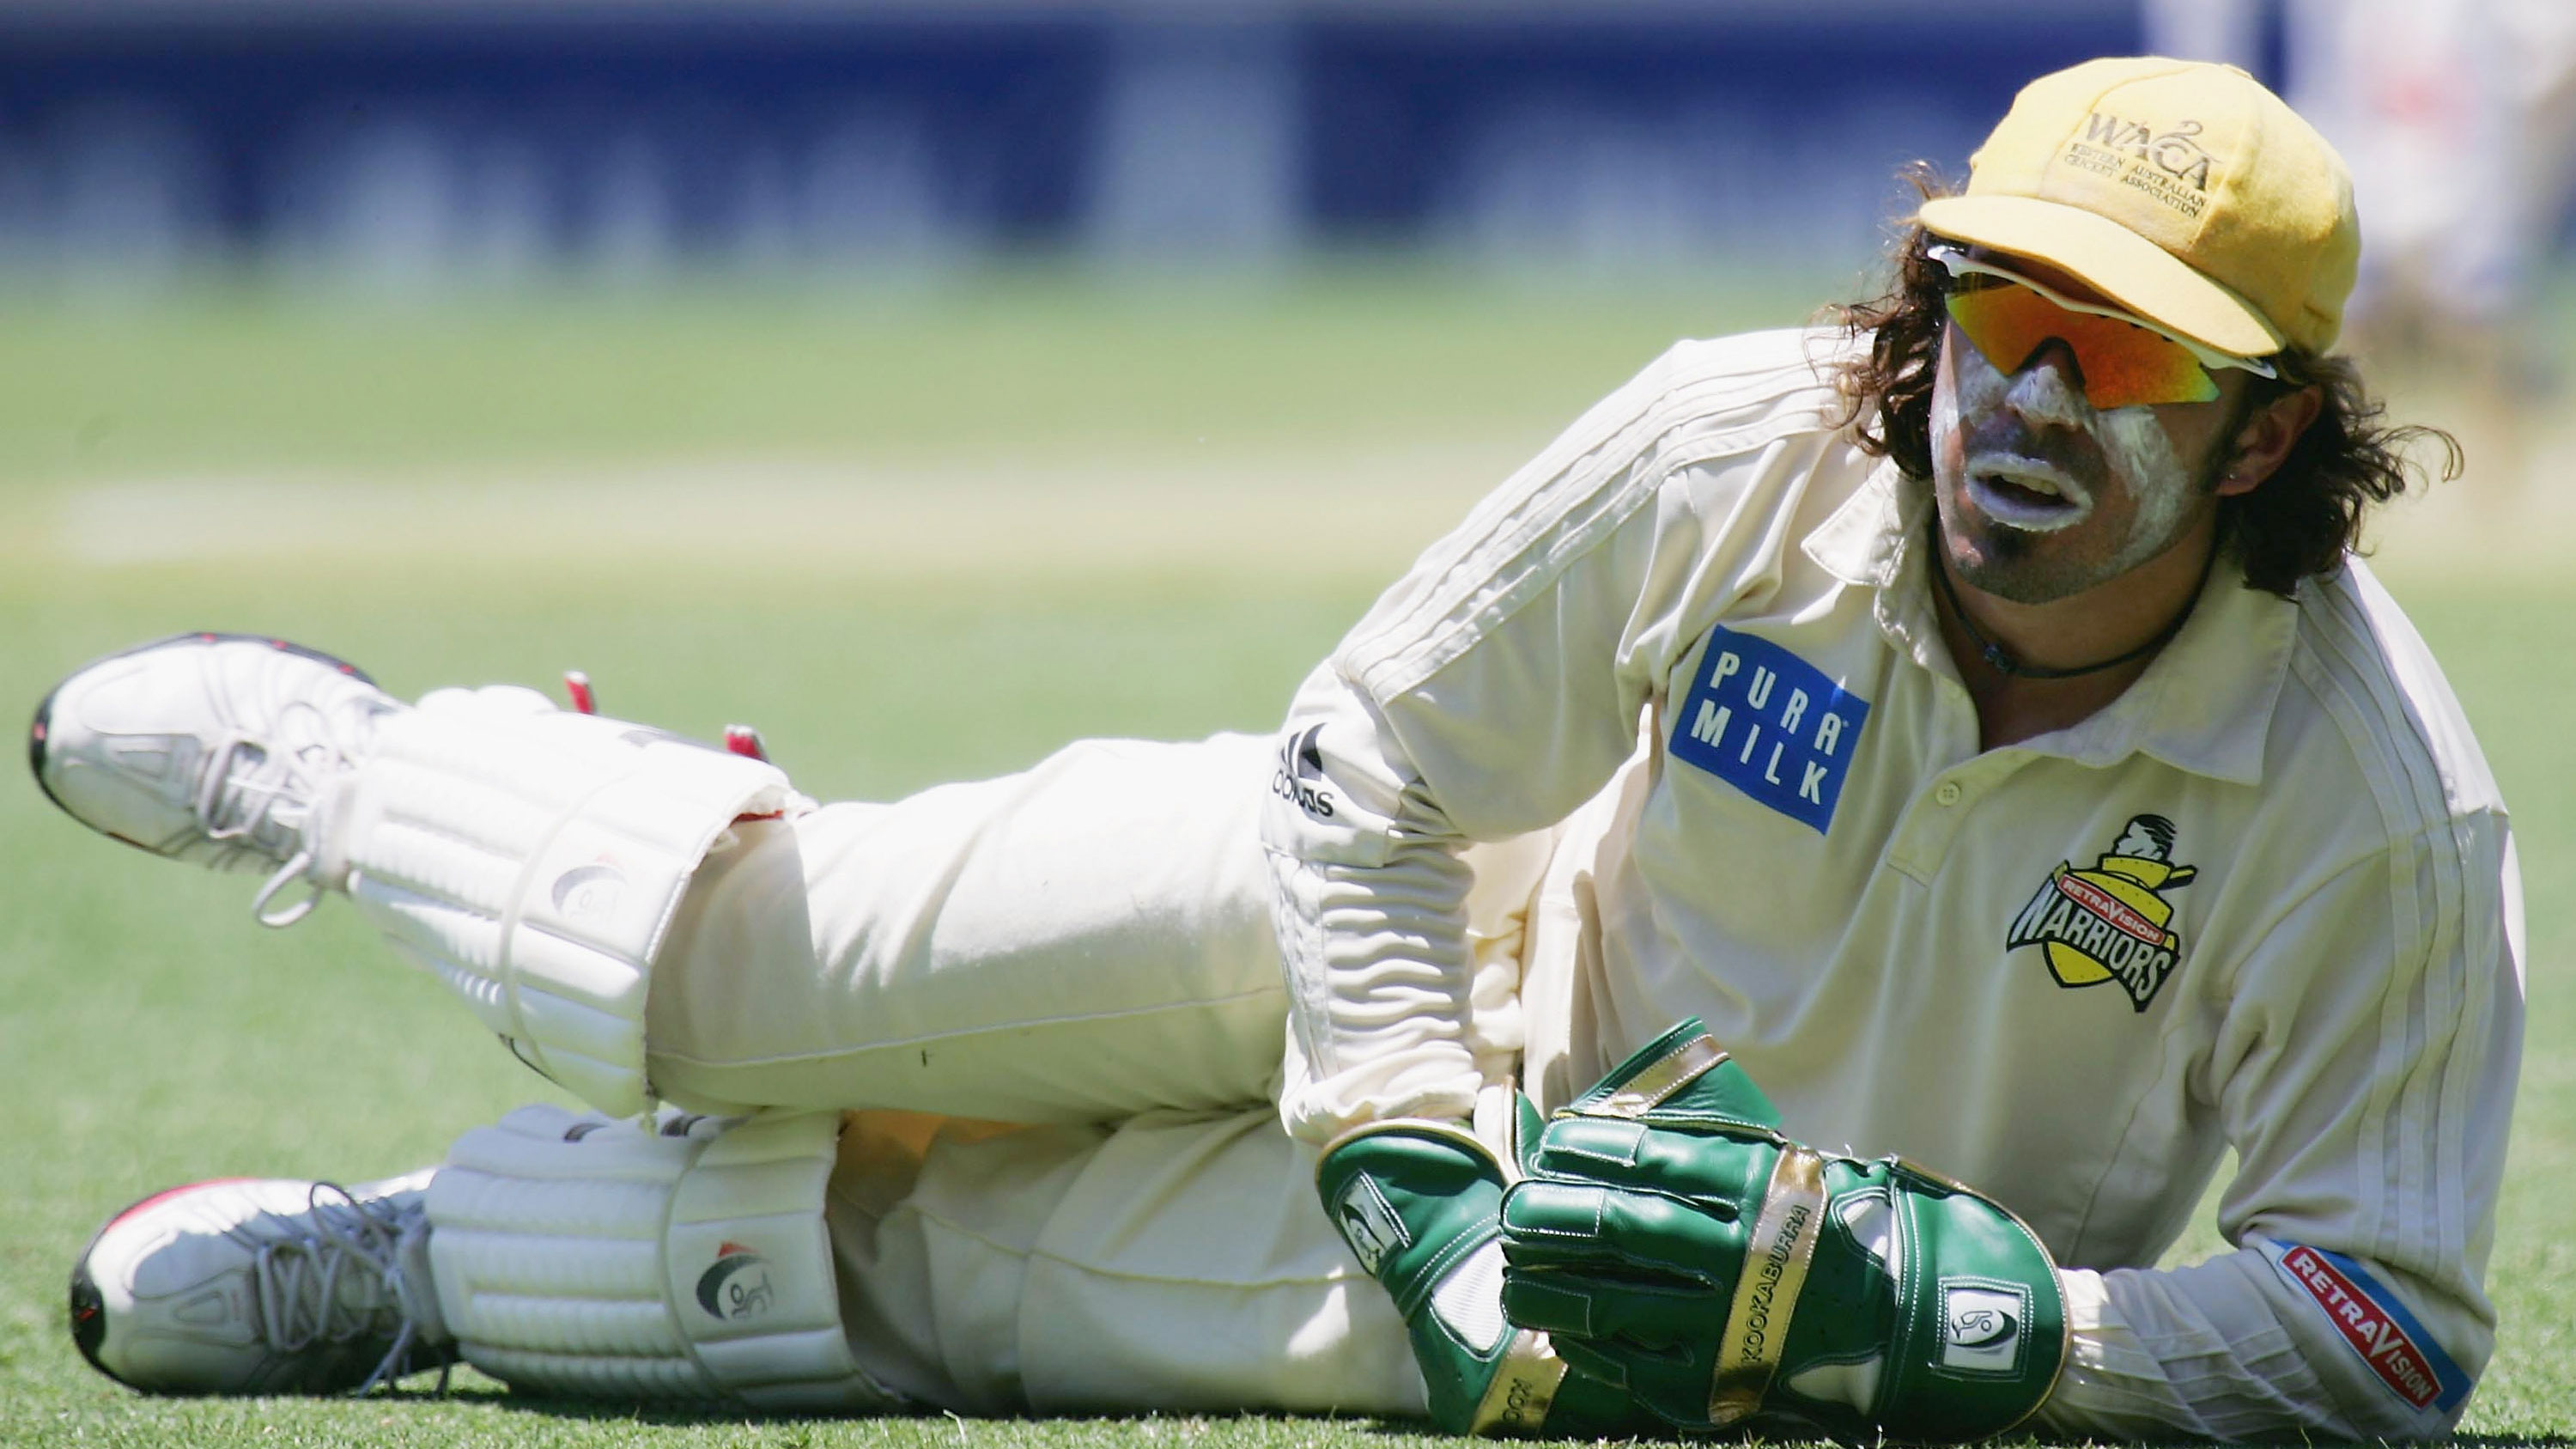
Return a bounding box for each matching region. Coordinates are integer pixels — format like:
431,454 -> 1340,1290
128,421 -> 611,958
26,634 -> 404,926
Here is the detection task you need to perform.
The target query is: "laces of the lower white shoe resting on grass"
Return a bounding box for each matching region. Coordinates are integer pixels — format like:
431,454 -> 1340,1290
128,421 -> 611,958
234,1184 -> 456,1395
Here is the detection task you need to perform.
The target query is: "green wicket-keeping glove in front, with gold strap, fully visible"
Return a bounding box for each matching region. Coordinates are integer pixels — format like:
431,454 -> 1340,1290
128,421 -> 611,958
1502,1021 -> 2066,1441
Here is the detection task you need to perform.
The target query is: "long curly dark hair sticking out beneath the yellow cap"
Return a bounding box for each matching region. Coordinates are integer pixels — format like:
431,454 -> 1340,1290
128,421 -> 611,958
1826,162 -> 2460,598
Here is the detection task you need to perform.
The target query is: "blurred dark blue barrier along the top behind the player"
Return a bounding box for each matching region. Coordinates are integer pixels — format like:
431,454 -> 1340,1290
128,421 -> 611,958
0,0 -> 2138,281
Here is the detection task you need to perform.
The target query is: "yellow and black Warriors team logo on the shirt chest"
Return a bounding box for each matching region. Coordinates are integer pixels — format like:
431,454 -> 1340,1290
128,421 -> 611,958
2004,815 -> 2200,1011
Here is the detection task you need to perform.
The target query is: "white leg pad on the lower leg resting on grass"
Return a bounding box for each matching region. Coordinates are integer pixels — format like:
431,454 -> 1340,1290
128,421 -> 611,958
428,1106 -> 896,1413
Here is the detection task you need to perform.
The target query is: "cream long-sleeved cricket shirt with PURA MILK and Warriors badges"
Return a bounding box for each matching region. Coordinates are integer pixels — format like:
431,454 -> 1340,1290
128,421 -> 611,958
1265,332 -> 2522,1436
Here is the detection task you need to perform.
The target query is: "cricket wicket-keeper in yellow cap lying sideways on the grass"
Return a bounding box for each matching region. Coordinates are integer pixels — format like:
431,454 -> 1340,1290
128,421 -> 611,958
31,59 -> 2522,1439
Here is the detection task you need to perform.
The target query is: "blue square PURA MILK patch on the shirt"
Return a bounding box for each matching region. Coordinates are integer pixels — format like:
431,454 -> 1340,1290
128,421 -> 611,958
1672,626 -> 1870,836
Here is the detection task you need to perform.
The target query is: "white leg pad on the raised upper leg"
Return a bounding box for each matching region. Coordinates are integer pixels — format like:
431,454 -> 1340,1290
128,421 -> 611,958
337,688 -> 804,1117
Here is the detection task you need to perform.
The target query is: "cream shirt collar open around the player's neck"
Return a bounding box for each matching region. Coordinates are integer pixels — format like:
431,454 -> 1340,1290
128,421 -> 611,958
1801,459 -> 2298,787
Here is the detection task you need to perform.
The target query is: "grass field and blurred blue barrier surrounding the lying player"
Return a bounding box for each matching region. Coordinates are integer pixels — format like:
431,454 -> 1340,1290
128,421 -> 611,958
0,0 -> 2576,1446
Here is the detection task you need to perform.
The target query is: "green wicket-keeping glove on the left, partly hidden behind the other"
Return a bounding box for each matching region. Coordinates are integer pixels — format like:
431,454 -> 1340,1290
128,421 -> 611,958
1314,1101 -> 1662,1439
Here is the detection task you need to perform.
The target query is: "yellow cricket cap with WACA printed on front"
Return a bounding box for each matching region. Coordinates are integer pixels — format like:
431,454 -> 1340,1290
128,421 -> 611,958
1917,57 -> 2362,356
